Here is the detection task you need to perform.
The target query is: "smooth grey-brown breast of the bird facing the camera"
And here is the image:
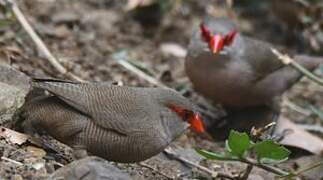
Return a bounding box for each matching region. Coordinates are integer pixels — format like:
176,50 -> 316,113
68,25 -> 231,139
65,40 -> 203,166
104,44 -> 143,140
186,54 -> 264,106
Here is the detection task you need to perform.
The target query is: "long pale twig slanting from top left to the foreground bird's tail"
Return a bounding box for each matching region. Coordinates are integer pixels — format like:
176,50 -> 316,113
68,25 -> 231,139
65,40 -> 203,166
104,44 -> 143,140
5,0 -> 84,82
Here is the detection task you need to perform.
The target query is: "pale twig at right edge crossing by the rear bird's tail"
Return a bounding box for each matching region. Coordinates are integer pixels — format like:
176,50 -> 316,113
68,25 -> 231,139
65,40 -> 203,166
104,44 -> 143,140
271,48 -> 323,86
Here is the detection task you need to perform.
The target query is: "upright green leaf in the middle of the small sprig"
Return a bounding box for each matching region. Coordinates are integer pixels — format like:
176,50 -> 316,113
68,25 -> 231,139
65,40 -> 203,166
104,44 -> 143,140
226,130 -> 252,157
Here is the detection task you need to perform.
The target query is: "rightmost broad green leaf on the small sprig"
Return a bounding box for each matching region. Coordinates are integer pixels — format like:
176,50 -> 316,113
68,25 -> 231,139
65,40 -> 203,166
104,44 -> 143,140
254,140 -> 290,164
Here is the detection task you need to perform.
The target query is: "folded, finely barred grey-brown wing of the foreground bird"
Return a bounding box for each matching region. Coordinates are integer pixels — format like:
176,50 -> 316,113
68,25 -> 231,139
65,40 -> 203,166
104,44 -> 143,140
33,79 -> 153,135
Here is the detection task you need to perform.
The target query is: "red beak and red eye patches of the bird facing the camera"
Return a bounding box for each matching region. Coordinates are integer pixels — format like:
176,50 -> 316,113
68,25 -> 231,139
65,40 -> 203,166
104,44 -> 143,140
200,22 -> 237,54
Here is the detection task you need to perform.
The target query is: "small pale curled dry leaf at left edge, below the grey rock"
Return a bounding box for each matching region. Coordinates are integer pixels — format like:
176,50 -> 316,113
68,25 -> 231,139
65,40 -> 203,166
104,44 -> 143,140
0,126 -> 29,145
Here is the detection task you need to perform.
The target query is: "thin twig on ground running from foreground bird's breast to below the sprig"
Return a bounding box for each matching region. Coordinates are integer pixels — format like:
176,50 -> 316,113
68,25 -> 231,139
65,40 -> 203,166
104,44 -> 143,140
164,148 -> 235,180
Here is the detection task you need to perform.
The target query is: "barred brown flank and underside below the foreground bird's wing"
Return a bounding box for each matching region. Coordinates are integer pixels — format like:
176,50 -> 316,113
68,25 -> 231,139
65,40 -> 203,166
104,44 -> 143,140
22,96 -> 169,162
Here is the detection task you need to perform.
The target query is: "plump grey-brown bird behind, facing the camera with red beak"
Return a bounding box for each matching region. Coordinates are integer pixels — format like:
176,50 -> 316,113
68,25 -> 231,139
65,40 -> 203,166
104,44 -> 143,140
185,18 -> 323,109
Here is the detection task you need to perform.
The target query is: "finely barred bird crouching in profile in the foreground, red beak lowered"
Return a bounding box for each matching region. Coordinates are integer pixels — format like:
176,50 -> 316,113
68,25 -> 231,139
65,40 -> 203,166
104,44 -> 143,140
21,79 -> 204,163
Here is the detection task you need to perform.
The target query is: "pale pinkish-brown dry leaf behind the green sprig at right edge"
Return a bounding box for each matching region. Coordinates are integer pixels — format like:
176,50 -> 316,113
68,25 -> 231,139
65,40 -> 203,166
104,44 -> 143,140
275,117 -> 323,155
